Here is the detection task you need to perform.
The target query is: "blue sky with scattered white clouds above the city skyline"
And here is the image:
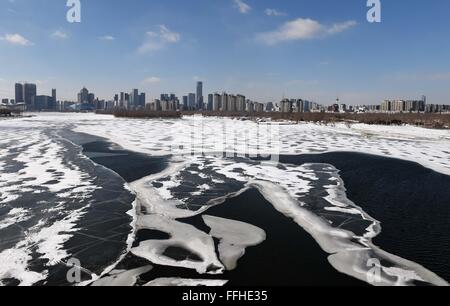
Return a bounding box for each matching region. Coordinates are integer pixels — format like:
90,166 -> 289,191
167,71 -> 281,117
0,0 -> 450,104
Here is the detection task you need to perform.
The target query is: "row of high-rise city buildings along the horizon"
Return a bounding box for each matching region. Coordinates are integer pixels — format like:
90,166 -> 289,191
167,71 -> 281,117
1,81 -> 450,113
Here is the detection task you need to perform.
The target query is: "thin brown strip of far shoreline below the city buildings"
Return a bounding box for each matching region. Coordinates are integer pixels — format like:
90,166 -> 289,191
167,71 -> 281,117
97,110 -> 450,129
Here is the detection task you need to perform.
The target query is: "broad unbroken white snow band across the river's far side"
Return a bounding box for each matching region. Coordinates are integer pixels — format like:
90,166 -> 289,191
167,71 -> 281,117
0,114 -> 450,175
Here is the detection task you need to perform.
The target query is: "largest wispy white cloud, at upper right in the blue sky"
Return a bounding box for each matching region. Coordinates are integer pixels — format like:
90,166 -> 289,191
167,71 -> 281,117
257,18 -> 356,45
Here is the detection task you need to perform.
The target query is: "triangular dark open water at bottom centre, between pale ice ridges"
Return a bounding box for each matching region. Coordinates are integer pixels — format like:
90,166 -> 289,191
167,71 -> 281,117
183,189 -> 364,286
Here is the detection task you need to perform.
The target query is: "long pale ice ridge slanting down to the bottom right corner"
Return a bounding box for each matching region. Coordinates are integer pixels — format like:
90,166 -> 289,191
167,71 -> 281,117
253,181 -> 448,286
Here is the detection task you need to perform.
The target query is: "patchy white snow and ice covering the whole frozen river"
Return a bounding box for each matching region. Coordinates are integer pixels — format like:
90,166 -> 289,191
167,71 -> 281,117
0,114 -> 450,285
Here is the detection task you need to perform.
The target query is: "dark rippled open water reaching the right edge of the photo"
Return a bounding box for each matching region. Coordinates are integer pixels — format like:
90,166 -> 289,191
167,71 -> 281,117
281,153 -> 450,281
